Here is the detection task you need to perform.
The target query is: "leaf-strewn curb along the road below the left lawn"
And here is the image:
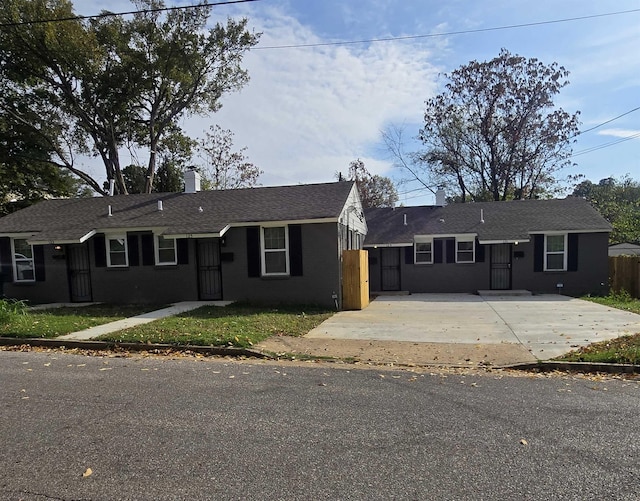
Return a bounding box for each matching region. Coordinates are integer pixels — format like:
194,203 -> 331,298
0,337 -> 273,358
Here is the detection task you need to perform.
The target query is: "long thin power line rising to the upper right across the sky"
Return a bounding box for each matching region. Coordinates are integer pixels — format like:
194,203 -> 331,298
252,9 -> 640,50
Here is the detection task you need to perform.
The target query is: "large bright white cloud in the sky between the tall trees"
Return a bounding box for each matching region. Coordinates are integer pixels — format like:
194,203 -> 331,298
198,9 -> 438,184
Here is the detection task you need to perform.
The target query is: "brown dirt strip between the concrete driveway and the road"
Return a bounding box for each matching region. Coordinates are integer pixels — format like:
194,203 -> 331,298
255,336 -> 536,367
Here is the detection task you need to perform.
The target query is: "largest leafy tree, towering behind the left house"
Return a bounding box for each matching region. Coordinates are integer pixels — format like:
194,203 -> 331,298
0,0 -> 258,195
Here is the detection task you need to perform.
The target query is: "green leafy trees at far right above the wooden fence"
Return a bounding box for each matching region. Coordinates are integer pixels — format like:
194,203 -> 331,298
573,175 -> 640,244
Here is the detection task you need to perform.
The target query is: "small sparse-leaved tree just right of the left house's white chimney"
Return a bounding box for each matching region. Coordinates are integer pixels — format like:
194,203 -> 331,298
198,125 -> 263,190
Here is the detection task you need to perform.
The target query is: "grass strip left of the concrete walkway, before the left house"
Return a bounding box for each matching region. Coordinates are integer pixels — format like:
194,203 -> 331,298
0,304 -> 162,338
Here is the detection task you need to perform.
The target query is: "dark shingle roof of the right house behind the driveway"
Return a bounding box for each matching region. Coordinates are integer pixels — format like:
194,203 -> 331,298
365,197 -> 611,245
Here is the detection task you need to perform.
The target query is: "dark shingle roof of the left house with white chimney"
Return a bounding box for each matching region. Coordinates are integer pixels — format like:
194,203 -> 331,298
0,182 -> 353,241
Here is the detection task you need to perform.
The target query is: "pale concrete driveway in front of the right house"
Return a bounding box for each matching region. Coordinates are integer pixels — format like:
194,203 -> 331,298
305,294 -> 640,360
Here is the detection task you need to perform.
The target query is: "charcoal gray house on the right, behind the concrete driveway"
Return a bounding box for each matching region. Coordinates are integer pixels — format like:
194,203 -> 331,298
365,197 -> 611,296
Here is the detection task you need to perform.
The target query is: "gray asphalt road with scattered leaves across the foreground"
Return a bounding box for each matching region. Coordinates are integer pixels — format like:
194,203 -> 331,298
0,351 -> 640,501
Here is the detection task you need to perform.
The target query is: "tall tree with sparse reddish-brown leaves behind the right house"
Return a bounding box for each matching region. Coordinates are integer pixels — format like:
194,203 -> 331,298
410,49 -> 578,202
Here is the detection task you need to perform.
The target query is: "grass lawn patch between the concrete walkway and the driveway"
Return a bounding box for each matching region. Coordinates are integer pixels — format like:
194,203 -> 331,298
100,303 -> 334,348
